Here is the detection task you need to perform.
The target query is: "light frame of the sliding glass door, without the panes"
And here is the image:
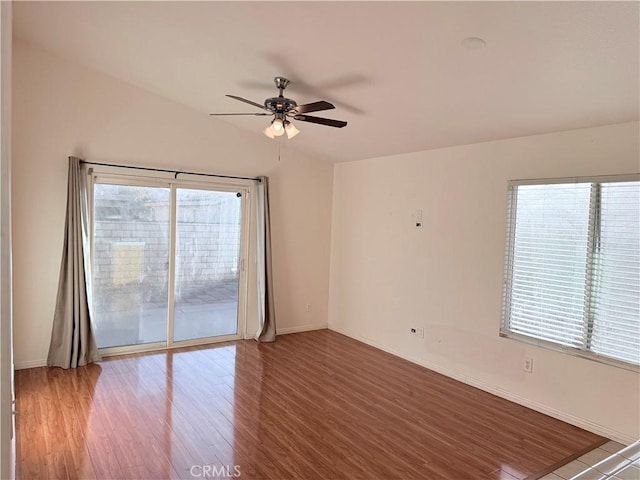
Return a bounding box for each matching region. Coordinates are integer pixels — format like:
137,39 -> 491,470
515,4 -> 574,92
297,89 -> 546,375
86,168 -> 254,356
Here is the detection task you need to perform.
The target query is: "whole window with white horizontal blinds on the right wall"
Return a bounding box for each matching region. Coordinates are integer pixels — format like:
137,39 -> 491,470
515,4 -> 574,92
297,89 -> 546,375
500,176 -> 640,369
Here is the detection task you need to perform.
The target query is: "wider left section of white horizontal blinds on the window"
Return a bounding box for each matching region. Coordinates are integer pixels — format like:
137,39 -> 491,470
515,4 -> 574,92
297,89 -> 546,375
503,183 -> 591,348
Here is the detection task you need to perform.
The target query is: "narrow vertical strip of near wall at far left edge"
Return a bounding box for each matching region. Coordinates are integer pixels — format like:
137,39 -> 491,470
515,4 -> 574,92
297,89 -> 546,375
0,2 -> 15,478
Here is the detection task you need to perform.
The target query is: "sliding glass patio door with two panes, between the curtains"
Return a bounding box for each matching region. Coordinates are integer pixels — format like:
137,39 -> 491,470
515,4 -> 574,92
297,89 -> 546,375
92,175 -> 247,353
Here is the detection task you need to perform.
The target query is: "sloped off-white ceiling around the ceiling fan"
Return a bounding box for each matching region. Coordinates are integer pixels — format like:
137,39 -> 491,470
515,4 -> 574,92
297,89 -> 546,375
14,1 -> 640,161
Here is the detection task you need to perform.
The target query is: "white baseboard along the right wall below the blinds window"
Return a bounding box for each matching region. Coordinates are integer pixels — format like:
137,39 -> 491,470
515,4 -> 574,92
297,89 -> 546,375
328,326 -> 638,445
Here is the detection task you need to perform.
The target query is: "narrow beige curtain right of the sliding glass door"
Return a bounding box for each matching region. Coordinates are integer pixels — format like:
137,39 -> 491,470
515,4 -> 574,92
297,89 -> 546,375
256,177 -> 276,342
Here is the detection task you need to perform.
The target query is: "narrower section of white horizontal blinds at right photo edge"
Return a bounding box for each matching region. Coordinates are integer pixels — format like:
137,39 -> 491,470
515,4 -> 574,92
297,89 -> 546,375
590,182 -> 640,364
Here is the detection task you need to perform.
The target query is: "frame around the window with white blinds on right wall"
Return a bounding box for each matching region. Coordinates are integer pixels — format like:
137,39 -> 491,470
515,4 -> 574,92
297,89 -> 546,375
499,173 -> 640,372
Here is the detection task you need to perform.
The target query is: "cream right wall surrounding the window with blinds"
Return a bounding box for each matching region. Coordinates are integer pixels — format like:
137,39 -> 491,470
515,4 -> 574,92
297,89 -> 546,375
329,122 -> 640,441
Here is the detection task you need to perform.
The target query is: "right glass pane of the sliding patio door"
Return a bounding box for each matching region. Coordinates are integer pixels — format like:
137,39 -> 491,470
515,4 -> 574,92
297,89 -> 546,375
174,188 -> 242,341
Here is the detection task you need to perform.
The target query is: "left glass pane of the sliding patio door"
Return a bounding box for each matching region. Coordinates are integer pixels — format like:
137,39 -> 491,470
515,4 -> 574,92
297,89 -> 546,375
93,184 -> 170,348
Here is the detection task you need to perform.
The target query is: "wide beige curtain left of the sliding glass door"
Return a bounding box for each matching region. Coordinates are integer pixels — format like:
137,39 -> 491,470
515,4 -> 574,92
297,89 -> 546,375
47,157 -> 100,368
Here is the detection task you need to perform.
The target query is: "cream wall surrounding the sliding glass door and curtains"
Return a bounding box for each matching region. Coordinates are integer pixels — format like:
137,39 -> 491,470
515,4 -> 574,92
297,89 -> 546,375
12,41 -> 333,368
